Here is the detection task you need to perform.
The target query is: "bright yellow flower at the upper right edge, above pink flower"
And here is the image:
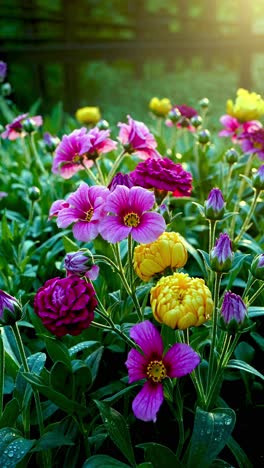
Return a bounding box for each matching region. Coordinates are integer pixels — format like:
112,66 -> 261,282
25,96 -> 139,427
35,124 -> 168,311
226,88 -> 264,122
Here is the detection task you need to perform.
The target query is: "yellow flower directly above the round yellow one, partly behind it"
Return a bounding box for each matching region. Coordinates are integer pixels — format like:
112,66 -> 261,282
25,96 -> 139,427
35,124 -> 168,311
133,232 -> 188,281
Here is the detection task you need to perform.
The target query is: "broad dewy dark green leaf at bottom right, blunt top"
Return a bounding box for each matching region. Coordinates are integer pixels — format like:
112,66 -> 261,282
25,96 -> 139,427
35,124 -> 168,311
186,407 -> 236,468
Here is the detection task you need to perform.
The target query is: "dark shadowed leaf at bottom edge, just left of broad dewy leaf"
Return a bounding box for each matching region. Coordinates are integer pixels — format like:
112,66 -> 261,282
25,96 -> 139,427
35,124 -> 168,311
137,442 -> 182,468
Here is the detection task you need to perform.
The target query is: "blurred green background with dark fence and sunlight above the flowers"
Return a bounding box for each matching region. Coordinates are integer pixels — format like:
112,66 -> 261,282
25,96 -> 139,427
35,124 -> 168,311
0,0 -> 264,123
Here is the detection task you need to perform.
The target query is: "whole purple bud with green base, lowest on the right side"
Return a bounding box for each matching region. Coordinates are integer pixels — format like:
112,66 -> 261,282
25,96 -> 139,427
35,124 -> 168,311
220,291 -> 247,334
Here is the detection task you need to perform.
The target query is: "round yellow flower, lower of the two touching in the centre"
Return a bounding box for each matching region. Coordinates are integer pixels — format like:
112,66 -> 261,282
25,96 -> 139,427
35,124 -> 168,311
150,273 -> 213,330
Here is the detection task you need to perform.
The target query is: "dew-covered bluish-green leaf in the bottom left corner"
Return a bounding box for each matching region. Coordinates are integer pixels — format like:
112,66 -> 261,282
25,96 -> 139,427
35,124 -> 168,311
0,427 -> 35,468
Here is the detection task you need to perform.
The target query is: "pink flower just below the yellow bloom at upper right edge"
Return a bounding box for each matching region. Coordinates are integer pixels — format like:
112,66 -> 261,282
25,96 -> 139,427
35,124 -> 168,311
218,114 -> 262,143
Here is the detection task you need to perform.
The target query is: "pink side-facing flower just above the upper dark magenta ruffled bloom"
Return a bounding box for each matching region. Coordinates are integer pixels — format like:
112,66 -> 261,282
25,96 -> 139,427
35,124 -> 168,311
118,115 -> 161,159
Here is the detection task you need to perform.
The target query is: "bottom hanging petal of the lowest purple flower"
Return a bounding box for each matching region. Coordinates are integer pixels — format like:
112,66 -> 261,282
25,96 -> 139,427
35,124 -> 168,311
132,381 -> 164,422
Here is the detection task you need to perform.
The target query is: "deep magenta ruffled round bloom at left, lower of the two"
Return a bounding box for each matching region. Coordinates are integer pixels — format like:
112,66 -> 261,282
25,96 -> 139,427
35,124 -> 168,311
34,276 -> 97,336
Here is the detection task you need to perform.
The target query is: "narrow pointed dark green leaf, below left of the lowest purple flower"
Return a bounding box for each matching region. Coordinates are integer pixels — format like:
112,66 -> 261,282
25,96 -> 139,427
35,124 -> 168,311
94,400 -> 135,466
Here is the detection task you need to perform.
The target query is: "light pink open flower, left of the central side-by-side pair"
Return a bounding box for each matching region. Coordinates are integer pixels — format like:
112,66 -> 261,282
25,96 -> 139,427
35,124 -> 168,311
50,183 -> 110,242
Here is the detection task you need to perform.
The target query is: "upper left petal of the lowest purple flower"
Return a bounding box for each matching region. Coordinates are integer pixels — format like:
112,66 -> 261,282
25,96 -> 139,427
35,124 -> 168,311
130,320 -> 163,359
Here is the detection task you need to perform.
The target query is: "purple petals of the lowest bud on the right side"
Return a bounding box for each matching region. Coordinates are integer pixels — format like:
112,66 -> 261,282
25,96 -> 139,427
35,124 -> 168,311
221,291 -> 247,324
